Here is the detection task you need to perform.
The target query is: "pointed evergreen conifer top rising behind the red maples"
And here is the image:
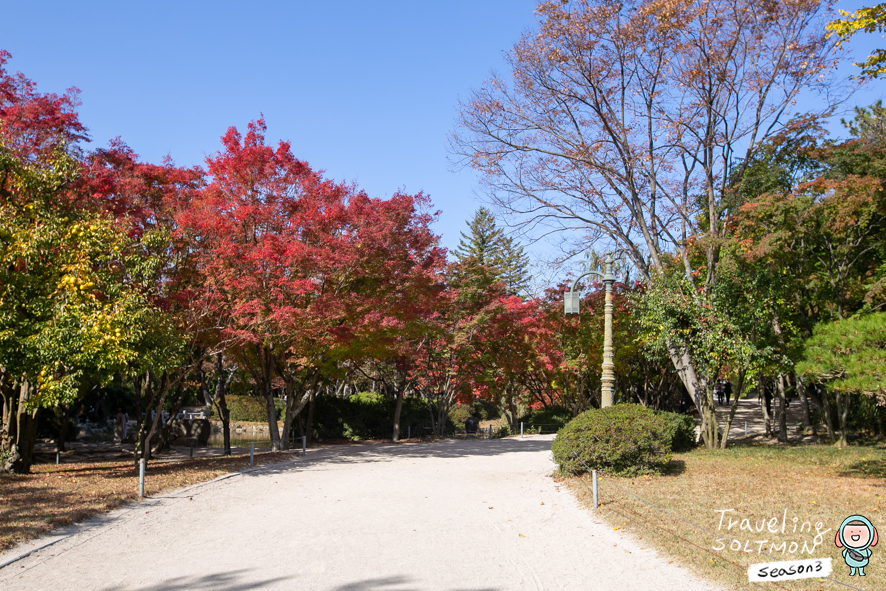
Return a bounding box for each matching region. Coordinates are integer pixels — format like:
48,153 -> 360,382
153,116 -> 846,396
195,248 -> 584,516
454,207 -> 529,295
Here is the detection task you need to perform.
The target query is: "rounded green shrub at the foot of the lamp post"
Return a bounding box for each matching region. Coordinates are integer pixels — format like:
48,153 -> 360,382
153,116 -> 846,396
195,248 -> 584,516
551,404 -> 671,476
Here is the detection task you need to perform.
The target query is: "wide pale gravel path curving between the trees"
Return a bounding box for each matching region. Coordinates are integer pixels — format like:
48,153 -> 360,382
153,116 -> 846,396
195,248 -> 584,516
0,435 -> 711,591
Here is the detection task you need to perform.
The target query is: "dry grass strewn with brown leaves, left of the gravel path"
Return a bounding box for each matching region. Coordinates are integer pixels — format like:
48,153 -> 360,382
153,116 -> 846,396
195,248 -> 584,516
0,452 -> 291,552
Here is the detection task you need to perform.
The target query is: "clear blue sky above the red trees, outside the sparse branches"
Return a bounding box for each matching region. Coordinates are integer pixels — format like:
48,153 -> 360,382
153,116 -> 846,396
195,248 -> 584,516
0,0 -> 886,260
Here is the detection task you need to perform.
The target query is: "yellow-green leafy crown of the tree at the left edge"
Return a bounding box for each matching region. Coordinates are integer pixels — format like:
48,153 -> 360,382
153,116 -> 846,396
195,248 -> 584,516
0,146 -> 180,407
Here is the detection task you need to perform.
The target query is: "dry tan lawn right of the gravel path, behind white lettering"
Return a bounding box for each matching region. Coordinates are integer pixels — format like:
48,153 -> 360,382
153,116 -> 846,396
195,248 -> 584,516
568,445 -> 886,590
